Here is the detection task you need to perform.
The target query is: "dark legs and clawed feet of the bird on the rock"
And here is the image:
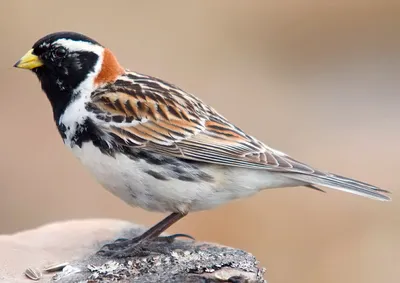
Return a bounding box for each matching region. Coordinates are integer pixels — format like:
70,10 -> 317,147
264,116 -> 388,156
97,212 -> 193,257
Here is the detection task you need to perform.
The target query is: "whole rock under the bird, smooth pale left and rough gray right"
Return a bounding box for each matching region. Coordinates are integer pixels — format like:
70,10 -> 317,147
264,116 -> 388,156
0,222 -> 265,283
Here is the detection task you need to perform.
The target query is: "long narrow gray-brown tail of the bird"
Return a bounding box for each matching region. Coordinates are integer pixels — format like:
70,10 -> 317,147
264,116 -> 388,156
287,171 -> 390,201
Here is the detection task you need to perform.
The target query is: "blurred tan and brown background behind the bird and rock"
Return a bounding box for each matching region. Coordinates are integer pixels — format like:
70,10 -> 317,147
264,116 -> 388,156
0,0 -> 400,283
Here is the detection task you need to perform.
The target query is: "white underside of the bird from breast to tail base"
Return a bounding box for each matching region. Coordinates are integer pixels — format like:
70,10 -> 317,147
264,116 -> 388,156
66,142 -> 296,212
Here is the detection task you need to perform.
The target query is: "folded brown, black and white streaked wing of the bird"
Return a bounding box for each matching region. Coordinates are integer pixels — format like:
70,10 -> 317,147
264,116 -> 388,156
86,73 -> 315,174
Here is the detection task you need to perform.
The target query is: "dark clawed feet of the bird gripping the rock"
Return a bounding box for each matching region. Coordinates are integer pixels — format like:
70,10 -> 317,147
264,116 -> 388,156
97,234 -> 194,258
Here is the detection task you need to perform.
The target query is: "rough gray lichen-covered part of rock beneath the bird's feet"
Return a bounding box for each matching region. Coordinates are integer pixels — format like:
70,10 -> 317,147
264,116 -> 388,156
53,225 -> 264,283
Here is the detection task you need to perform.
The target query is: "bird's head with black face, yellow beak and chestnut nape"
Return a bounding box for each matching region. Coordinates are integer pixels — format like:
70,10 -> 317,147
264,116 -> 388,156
14,32 -> 124,117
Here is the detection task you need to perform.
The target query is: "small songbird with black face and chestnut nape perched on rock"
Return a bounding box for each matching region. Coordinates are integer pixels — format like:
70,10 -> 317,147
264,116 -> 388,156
15,32 -> 390,257
